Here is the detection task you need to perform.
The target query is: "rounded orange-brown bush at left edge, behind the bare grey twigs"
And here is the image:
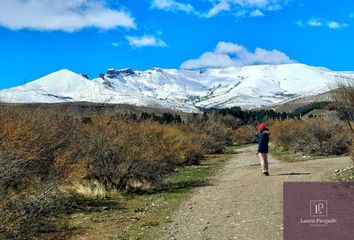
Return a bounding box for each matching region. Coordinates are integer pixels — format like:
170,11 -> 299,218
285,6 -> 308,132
0,111 -> 79,186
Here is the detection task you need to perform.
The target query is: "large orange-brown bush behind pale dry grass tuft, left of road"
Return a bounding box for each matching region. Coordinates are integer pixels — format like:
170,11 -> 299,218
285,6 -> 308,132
84,117 -> 206,190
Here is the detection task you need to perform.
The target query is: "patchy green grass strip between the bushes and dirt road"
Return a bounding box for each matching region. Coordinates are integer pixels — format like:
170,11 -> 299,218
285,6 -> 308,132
53,148 -> 234,240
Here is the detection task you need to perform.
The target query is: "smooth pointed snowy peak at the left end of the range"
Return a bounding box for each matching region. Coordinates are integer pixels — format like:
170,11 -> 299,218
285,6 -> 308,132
0,69 -> 199,111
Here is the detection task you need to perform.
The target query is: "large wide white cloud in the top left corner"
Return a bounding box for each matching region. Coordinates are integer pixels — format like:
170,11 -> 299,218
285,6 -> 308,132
0,0 -> 136,32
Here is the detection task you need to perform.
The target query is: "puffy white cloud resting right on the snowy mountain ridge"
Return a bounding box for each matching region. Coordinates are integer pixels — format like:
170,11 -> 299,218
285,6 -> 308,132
181,42 -> 294,69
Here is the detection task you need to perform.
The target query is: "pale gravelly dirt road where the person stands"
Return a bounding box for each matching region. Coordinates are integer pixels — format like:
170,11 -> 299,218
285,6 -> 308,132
163,146 -> 352,240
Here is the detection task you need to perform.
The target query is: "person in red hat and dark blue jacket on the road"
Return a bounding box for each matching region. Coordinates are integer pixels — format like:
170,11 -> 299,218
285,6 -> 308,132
257,123 -> 270,176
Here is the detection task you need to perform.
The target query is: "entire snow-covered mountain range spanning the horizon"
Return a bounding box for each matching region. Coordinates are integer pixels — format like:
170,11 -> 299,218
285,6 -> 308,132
0,63 -> 354,112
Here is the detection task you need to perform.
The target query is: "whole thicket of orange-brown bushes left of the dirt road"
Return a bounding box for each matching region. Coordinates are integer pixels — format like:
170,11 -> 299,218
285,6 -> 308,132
0,106 -> 231,239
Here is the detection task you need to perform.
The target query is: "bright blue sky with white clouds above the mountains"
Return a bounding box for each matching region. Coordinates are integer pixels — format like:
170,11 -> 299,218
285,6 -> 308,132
0,0 -> 354,89
